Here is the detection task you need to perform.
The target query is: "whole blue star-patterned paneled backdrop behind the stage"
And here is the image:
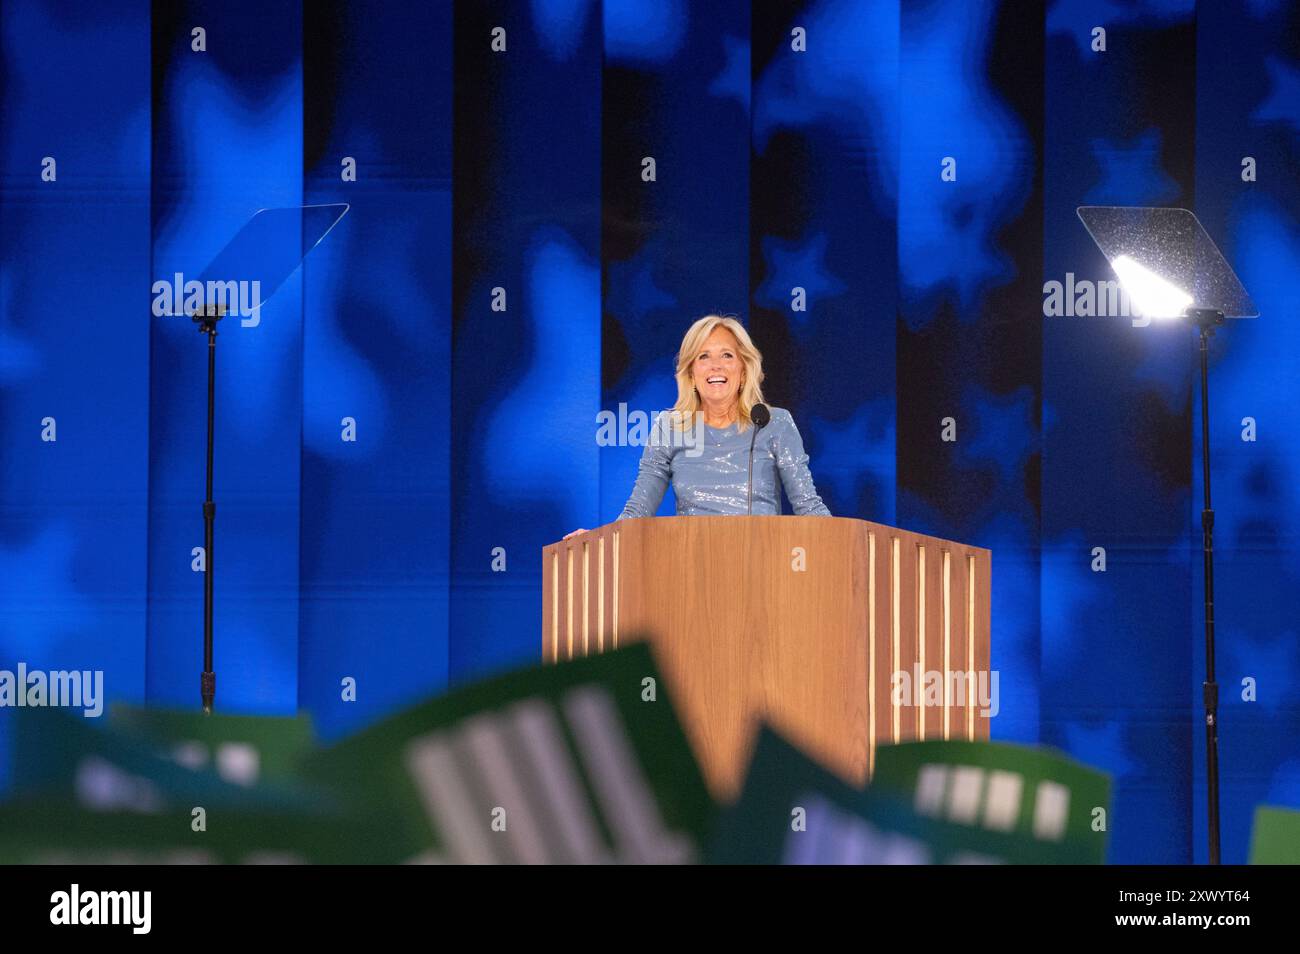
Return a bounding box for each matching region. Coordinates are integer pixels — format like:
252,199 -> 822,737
0,0 -> 1300,863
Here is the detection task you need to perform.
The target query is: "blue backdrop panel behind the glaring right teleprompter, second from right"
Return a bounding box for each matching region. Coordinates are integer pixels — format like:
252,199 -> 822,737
1034,0 -> 1196,864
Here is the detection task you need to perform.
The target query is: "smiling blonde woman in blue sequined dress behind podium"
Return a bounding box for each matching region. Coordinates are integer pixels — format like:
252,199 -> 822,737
567,315 -> 831,537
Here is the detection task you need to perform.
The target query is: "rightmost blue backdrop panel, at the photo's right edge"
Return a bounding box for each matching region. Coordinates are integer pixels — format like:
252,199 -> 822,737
1178,3 -> 1300,864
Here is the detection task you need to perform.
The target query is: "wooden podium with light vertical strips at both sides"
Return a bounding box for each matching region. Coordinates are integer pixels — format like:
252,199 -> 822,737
542,516 -> 991,801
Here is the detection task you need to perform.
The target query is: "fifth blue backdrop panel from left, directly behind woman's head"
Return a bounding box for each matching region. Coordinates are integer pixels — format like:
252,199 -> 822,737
600,0 -> 763,526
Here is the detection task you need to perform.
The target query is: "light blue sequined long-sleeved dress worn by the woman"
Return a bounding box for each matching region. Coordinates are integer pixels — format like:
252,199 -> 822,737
619,407 -> 831,520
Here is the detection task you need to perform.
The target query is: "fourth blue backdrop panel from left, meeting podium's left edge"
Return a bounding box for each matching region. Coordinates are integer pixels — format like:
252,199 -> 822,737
450,0 -> 601,682
